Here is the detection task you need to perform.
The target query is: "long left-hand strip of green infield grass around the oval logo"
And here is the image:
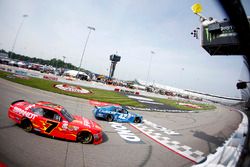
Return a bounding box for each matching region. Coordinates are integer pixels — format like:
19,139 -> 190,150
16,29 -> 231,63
0,71 -> 144,107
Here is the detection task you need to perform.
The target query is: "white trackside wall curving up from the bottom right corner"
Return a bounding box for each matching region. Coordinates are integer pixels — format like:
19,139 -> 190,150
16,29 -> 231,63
193,110 -> 248,167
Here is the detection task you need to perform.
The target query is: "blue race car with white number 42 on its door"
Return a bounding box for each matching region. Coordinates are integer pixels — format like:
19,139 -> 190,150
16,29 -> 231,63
93,106 -> 142,123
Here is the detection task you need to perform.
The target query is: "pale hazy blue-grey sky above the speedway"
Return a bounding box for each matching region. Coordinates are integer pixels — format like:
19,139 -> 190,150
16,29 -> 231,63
0,0 -> 250,97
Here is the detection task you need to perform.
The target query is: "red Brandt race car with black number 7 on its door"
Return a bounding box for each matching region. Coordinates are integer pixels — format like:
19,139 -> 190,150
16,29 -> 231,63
8,100 -> 102,144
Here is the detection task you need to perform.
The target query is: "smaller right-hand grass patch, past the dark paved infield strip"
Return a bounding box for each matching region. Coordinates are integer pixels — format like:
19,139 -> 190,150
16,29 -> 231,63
154,98 -> 216,110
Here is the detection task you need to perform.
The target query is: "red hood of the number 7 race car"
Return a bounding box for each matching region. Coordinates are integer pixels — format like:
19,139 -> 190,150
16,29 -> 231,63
71,115 -> 101,131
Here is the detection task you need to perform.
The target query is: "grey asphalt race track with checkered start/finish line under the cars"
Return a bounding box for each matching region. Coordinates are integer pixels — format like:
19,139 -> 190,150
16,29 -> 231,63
0,79 -> 241,167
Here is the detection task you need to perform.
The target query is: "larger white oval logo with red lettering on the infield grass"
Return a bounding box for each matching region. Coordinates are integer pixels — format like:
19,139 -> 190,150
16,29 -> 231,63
54,84 -> 91,94
